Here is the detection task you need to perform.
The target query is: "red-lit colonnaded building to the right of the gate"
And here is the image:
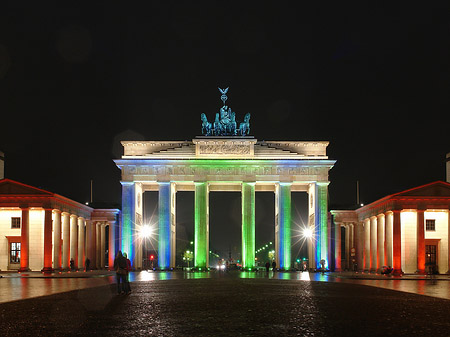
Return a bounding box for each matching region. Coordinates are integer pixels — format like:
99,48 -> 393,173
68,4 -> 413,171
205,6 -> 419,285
330,181 -> 450,275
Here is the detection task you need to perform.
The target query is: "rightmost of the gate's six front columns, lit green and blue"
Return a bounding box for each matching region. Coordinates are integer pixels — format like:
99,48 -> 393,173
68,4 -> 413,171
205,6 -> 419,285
315,182 -> 329,268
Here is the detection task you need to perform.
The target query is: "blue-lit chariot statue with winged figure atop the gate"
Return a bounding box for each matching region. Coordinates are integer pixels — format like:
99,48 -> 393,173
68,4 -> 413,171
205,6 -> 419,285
200,88 -> 250,136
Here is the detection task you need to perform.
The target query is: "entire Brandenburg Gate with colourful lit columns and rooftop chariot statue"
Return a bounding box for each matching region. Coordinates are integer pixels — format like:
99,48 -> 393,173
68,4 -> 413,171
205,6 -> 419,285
115,89 -> 335,270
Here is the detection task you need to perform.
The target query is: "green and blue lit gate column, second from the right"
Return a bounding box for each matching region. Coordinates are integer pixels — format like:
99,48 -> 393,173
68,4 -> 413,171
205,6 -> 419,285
275,183 -> 292,270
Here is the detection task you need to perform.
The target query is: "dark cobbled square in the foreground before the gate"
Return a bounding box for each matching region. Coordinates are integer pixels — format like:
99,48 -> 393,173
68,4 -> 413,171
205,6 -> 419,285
0,275 -> 450,336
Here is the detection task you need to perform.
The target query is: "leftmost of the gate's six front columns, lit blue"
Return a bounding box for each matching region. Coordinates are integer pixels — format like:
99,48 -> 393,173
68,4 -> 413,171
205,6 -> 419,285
120,181 -> 136,264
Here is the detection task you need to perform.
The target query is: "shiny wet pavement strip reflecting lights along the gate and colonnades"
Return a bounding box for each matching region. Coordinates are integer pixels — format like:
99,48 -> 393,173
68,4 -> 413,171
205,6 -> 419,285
0,271 -> 450,303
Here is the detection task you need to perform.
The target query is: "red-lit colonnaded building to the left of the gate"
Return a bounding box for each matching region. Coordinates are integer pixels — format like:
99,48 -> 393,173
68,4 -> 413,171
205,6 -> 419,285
0,179 -> 120,271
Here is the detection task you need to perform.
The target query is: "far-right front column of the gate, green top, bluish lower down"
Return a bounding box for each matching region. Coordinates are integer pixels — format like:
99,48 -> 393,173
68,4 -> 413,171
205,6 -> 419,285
316,183 -> 330,268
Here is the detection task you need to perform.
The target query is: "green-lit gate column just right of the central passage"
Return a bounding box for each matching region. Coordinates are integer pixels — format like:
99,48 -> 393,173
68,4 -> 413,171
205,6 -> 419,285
241,183 -> 255,268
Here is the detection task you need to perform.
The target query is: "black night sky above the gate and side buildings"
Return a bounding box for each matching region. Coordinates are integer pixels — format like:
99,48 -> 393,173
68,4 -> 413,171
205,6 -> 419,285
0,1 -> 450,258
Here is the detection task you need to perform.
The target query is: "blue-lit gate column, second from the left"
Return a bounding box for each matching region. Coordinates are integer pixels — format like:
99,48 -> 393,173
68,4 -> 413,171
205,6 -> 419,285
158,182 -> 175,269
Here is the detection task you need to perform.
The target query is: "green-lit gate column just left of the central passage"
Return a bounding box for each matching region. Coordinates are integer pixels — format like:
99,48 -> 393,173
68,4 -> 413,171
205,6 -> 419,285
194,182 -> 209,268
